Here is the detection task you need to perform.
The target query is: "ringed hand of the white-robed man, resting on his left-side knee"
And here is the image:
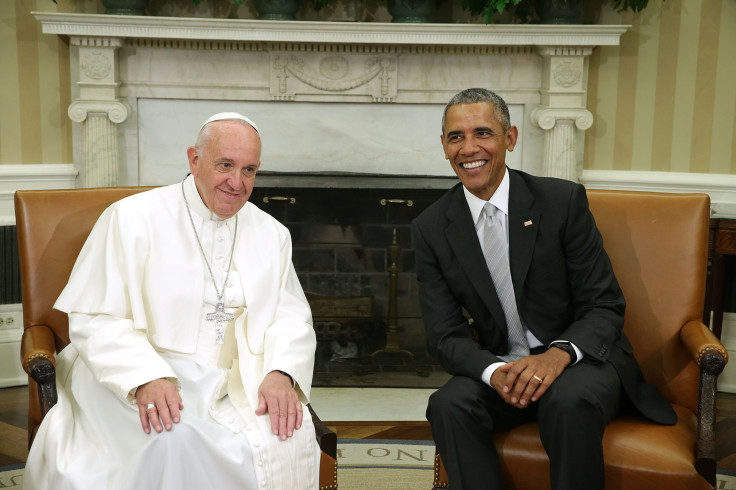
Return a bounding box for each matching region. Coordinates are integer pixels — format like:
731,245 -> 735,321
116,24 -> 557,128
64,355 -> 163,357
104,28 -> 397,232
135,378 -> 184,434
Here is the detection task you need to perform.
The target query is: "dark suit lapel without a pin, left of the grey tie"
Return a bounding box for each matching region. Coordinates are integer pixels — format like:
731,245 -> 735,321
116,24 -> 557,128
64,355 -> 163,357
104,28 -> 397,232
445,186 -> 506,331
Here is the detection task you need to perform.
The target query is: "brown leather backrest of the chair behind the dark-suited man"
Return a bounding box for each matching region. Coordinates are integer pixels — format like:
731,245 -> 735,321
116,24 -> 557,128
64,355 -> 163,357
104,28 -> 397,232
588,190 -> 710,413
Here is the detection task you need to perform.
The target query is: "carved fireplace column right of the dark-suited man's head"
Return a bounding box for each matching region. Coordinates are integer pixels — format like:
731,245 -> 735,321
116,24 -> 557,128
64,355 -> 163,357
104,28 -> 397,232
531,46 -> 593,182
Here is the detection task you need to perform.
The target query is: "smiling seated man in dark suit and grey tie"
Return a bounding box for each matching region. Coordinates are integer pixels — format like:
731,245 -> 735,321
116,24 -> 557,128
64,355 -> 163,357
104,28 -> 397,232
413,89 -> 676,490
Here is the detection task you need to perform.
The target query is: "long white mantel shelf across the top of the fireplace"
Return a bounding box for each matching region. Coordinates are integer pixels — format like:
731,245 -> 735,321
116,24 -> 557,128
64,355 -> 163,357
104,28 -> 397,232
33,12 -> 630,47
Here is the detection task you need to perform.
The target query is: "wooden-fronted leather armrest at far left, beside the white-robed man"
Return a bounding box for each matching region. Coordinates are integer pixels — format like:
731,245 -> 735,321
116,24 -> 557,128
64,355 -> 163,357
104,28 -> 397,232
20,325 -> 57,417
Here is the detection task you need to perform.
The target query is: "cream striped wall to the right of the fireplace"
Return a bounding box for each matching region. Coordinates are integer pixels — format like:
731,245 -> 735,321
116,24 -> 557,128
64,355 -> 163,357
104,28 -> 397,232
584,0 -> 736,174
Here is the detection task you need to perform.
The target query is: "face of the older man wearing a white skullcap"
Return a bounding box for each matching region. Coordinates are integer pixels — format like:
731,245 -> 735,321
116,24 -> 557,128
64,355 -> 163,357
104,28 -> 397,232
187,121 -> 261,219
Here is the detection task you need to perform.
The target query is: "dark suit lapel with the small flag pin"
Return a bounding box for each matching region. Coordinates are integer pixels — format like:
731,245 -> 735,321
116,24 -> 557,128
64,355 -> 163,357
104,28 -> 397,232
508,170 -> 541,296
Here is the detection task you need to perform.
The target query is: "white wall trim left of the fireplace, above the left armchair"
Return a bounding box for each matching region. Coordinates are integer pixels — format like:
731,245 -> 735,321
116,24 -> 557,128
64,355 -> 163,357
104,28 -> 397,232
0,163 -> 77,226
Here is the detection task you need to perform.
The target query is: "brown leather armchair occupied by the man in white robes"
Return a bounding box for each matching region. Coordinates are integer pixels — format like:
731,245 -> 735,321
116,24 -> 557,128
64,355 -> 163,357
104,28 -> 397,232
15,187 -> 337,490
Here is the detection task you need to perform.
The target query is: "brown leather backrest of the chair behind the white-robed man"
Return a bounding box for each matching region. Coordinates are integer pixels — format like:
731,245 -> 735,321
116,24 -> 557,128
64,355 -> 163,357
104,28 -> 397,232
15,187 -> 150,352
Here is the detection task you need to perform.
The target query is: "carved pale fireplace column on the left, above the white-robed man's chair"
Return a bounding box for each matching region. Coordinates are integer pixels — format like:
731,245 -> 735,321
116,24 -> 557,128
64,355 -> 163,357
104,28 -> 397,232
68,37 -> 131,187
